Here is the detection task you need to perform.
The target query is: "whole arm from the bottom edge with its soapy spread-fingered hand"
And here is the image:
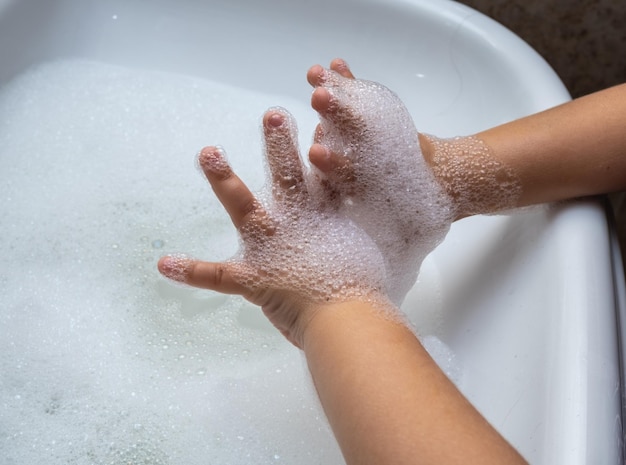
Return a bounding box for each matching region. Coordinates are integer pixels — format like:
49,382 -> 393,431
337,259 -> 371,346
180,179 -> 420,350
159,106 -> 524,465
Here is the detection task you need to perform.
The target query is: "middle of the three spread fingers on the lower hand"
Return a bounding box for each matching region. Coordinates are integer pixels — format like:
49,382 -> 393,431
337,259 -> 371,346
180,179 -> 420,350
198,147 -> 268,233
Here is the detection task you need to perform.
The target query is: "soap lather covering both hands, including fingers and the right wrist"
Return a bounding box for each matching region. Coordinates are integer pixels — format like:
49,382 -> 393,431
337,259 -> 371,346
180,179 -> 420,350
160,69 -> 518,320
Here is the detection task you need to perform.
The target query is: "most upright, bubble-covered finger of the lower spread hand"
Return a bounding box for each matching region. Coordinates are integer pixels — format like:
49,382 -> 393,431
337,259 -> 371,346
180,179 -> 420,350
263,108 -> 306,202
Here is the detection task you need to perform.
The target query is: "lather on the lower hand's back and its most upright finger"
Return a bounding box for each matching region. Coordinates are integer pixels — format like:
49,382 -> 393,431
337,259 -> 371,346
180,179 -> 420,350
216,108 -> 385,302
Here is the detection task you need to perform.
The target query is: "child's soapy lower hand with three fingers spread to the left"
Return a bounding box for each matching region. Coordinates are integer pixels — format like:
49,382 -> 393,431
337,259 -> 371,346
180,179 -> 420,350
159,109 -> 385,346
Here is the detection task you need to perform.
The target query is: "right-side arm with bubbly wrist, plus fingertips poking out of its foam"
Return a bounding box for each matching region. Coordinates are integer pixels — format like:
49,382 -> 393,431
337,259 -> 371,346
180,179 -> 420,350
309,59 -> 626,219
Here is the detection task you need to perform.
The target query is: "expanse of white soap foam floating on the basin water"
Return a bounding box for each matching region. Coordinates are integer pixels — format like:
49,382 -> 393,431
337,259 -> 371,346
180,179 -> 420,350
0,61 -> 342,465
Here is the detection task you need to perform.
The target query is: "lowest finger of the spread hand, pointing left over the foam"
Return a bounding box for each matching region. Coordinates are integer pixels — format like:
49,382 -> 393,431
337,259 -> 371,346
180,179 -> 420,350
157,255 -> 249,295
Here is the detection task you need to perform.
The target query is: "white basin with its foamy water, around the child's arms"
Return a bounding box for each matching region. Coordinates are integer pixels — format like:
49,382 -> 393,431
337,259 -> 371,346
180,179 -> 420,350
0,0 -> 622,465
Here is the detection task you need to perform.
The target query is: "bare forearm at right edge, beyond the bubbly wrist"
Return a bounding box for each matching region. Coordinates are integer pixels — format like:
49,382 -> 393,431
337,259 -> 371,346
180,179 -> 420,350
421,85 -> 626,216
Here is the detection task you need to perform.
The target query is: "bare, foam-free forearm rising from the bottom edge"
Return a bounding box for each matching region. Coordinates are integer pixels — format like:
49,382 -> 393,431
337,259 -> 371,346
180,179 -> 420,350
303,302 -> 524,464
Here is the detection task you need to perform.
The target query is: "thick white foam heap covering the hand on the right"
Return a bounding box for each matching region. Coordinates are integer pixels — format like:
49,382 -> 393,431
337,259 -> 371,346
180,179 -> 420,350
312,71 -> 453,304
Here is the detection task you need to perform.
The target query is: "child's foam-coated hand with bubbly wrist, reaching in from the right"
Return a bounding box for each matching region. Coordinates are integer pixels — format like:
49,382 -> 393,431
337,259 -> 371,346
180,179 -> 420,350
307,64 -> 522,304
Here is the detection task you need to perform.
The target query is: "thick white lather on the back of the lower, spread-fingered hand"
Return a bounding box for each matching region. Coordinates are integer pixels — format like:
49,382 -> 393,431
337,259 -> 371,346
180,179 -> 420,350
237,204 -> 384,301
